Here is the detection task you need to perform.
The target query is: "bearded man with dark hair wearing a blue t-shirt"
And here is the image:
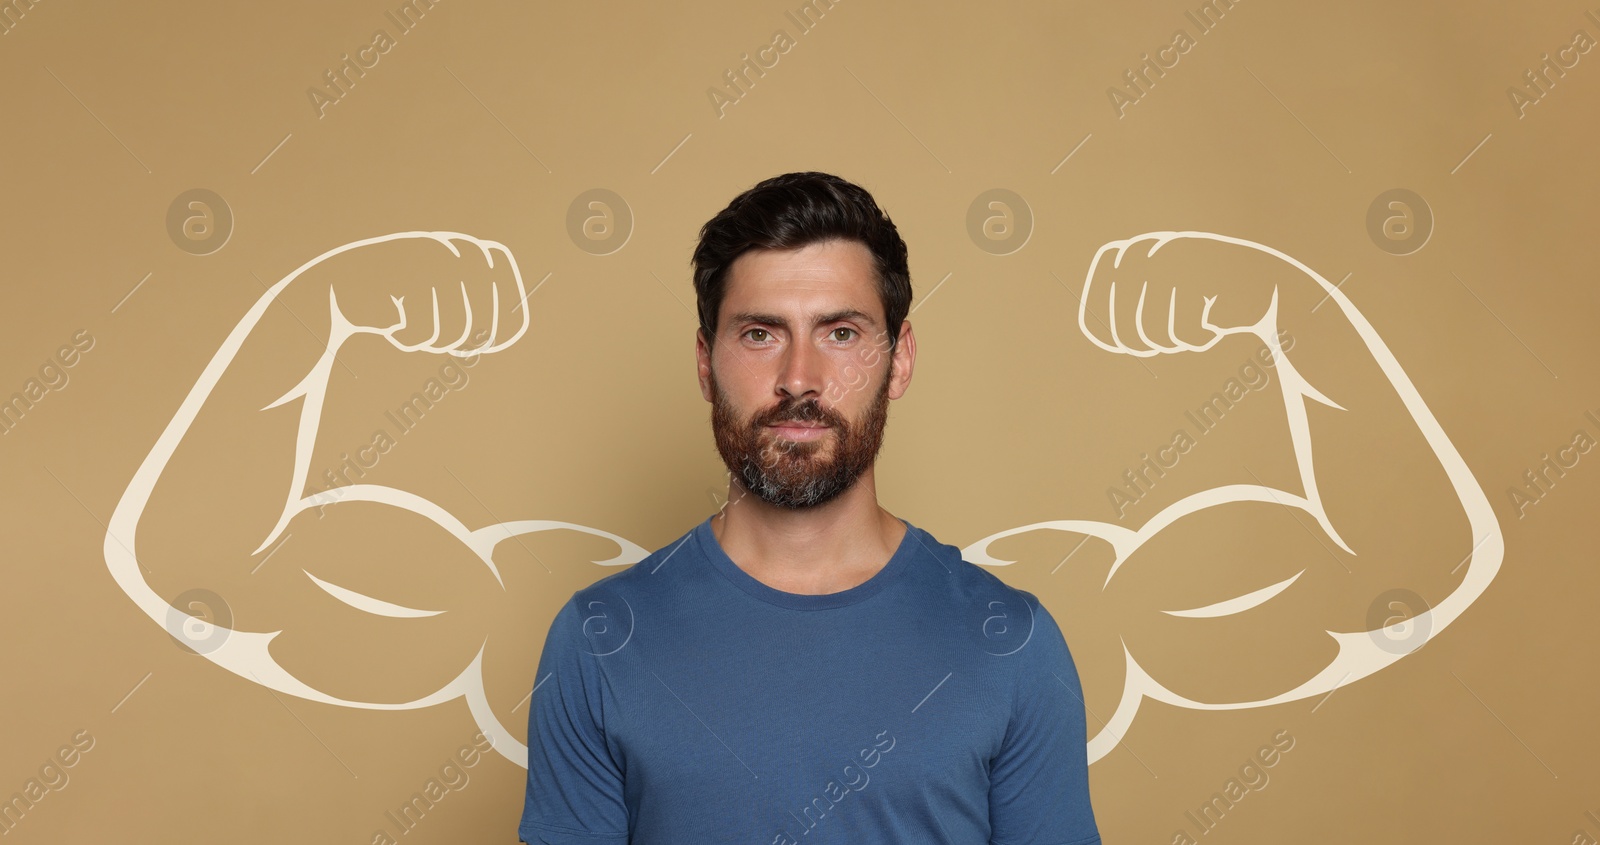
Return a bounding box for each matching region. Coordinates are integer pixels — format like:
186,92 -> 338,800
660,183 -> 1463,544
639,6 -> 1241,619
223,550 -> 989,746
518,173 -> 1099,845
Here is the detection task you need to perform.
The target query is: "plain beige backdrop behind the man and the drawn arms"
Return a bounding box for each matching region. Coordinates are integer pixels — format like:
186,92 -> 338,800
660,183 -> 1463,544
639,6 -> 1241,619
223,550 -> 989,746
0,0 -> 1600,845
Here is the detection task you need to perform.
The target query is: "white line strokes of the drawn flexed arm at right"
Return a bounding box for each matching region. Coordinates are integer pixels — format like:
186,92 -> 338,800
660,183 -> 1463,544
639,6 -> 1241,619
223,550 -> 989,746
962,232 -> 1506,763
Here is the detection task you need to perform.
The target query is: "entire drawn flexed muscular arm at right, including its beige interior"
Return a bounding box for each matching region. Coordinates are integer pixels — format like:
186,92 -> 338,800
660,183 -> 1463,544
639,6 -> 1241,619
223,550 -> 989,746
963,232 -> 1504,760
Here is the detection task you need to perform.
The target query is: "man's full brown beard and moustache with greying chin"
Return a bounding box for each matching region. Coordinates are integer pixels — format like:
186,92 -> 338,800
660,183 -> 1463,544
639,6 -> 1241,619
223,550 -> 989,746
710,363 -> 894,509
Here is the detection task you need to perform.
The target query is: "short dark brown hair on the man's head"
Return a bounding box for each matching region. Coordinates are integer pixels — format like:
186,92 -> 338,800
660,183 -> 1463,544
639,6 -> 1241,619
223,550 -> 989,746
693,171 -> 910,352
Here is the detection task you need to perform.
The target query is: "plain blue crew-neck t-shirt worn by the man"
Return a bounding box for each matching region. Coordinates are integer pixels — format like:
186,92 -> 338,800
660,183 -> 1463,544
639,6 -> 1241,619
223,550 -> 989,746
518,519 -> 1099,845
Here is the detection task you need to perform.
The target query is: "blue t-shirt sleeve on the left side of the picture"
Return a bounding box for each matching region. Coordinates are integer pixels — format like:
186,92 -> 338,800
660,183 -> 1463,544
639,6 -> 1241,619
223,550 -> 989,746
517,597 -> 629,845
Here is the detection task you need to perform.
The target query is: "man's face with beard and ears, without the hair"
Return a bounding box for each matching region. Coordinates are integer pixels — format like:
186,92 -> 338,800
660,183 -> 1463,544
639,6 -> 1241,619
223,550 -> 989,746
698,240 -> 912,509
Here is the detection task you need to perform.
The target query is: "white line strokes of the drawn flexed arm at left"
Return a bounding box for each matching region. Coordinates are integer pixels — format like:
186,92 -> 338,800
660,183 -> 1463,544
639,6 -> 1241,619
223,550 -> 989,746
104,232 -> 648,768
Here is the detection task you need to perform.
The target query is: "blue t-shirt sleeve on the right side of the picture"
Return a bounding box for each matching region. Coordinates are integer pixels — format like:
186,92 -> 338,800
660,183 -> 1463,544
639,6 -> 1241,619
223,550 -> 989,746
989,591 -> 1101,845
